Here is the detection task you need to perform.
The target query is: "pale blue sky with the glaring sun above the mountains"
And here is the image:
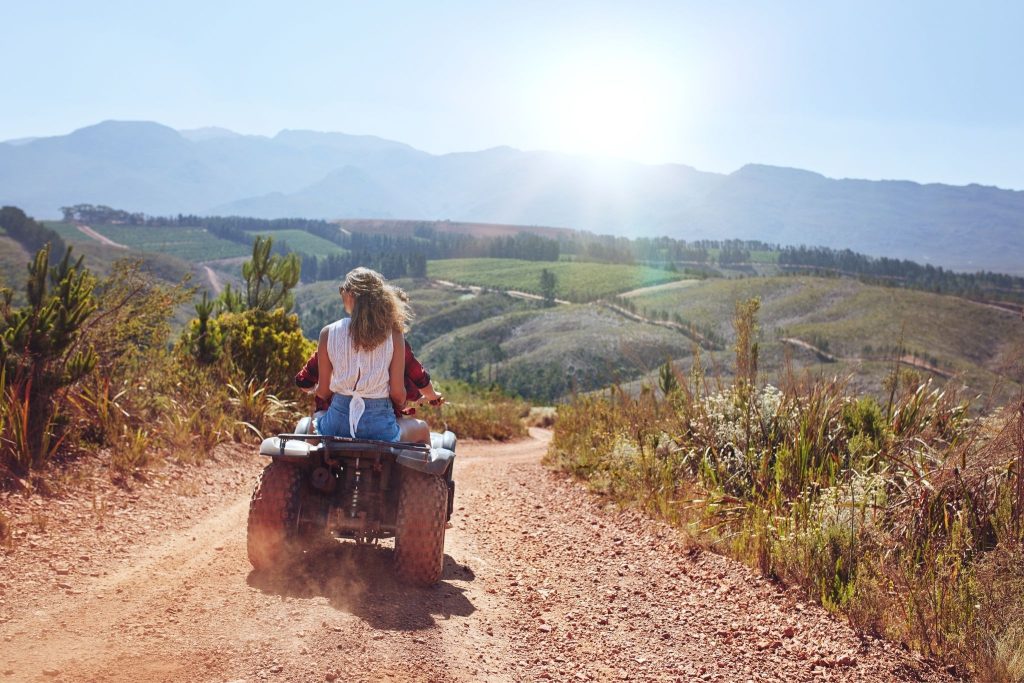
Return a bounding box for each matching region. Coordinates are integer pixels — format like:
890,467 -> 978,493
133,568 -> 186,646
0,0 -> 1024,188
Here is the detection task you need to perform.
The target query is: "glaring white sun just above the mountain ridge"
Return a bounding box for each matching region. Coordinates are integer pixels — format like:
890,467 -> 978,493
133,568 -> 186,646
544,53 -> 675,159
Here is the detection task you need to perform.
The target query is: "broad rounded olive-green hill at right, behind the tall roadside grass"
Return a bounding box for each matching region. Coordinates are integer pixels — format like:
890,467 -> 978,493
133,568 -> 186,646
630,276 -> 1024,392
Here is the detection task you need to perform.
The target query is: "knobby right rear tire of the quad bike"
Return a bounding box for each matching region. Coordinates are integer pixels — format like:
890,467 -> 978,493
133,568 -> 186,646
394,469 -> 449,586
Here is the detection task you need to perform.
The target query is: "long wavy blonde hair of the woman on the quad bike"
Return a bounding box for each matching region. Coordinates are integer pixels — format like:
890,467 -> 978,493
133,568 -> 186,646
338,266 -> 411,350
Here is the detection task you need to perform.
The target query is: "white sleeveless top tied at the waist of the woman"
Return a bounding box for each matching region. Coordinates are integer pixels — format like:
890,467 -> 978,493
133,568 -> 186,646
327,317 -> 394,435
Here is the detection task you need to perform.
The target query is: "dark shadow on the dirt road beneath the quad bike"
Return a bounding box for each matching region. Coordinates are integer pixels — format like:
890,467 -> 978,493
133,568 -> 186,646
247,543 -> 476,631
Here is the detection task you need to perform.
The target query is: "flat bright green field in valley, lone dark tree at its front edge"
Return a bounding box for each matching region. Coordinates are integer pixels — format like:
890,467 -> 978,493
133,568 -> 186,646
427,258 -> 682,302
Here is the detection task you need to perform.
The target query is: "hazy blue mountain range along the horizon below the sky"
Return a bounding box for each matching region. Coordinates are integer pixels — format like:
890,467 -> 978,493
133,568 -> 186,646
0,121 -> 1024,274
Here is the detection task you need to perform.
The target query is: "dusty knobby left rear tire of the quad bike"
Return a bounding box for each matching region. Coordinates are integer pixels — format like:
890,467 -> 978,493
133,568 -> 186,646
246,461 -> 302,570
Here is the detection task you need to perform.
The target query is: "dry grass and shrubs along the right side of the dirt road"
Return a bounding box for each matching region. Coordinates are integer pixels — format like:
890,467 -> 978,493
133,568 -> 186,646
548,305 -> 1024,681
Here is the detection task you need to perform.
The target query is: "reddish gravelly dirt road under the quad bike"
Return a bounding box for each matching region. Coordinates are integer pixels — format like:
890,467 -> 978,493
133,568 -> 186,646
0,429 -> 938,682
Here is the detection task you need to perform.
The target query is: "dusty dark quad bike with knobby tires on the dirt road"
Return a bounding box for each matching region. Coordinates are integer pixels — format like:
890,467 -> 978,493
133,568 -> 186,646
247,418 -> 456,586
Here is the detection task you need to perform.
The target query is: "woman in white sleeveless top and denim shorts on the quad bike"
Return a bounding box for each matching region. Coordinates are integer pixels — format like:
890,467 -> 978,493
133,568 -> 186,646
316,267 -> 430,441
